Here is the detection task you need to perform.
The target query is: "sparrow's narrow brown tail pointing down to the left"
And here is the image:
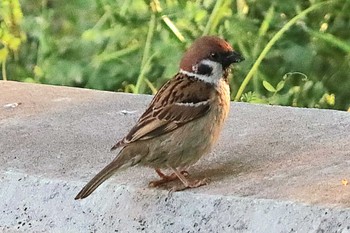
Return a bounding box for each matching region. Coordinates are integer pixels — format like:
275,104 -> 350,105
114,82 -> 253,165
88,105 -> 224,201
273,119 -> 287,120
74,147 -> 140,200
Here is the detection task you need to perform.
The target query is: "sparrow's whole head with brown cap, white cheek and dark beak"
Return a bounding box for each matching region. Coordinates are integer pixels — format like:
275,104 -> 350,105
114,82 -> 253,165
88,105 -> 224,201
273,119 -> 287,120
180,36 -> 244,81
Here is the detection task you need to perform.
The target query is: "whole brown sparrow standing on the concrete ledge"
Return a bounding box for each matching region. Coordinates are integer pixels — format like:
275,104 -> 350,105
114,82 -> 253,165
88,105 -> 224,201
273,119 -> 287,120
75,36 -> 244,199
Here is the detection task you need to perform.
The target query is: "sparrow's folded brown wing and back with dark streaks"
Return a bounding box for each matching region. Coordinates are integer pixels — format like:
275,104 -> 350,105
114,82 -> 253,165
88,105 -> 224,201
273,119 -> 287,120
112,74 -> 215,149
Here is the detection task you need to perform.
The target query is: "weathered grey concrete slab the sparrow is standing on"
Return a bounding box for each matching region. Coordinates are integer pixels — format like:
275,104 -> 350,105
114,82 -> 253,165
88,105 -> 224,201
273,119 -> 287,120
0,81 -> 350,233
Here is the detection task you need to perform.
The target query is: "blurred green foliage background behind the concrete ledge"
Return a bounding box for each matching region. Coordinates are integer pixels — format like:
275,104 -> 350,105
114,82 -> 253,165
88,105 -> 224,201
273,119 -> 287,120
0,0 -> 350,111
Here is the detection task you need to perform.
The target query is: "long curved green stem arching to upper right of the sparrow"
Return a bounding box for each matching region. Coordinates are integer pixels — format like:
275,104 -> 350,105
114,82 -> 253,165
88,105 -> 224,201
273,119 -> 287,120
234,0 -> 333,101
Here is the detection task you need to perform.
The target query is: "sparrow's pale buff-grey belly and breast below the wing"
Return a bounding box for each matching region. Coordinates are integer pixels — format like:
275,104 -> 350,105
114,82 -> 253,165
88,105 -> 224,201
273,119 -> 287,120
141,97 -> 229,168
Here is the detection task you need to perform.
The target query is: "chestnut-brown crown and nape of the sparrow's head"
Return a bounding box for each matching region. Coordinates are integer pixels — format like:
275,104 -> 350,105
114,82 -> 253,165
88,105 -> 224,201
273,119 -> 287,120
180,36 -> 233,72
